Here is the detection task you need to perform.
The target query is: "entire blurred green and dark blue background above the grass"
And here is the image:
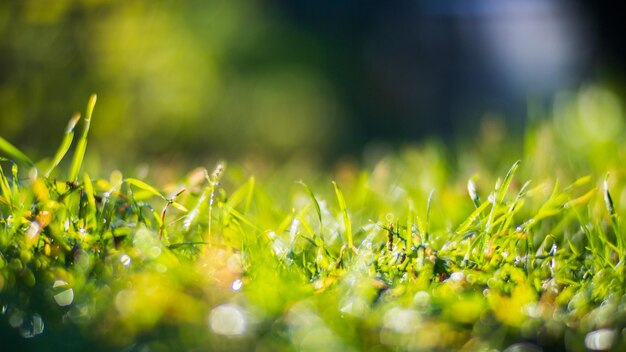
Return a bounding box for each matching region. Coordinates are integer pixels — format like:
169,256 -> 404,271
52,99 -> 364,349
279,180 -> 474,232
0,0 -> 626,172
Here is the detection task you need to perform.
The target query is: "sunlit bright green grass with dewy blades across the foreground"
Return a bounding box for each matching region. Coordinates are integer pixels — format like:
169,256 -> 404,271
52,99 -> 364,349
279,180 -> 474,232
0,88 -> 626,351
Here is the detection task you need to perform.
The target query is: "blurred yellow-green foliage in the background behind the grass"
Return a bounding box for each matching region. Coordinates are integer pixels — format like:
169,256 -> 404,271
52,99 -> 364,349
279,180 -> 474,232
0,0 -> 341,166
